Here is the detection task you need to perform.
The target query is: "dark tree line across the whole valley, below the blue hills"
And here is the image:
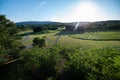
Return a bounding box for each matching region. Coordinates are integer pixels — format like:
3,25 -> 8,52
17,20 -> 120,33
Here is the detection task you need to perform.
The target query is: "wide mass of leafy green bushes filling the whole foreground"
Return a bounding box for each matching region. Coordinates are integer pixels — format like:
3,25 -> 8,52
1,46 -> 120,80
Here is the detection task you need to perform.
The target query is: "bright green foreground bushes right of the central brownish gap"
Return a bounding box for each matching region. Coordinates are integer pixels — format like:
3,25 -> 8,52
65,48 -> 120,80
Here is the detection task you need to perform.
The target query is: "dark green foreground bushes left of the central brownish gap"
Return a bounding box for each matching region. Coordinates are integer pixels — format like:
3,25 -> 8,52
5,47 -> 60,80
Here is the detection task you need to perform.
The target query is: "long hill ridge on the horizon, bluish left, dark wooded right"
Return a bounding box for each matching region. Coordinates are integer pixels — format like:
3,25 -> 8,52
16,20 -> 120,32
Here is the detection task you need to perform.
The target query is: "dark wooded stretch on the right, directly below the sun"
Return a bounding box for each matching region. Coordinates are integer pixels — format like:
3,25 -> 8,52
66,21 -> 120,32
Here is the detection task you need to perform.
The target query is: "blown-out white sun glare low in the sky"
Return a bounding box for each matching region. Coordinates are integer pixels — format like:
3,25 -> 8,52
73,2 -> 101,21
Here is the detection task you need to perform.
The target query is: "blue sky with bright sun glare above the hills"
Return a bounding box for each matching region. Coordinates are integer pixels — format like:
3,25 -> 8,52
0,0 -> 120,22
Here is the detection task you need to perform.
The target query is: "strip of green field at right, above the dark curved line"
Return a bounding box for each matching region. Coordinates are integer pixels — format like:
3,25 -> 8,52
70,31 -> 120,40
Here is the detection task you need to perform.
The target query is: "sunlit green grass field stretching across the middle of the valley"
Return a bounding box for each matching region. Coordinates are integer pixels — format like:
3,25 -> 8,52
22,31 -> 120,51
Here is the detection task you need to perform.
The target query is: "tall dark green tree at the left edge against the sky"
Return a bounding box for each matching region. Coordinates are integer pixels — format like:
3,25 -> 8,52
0,15 -> 23,64
